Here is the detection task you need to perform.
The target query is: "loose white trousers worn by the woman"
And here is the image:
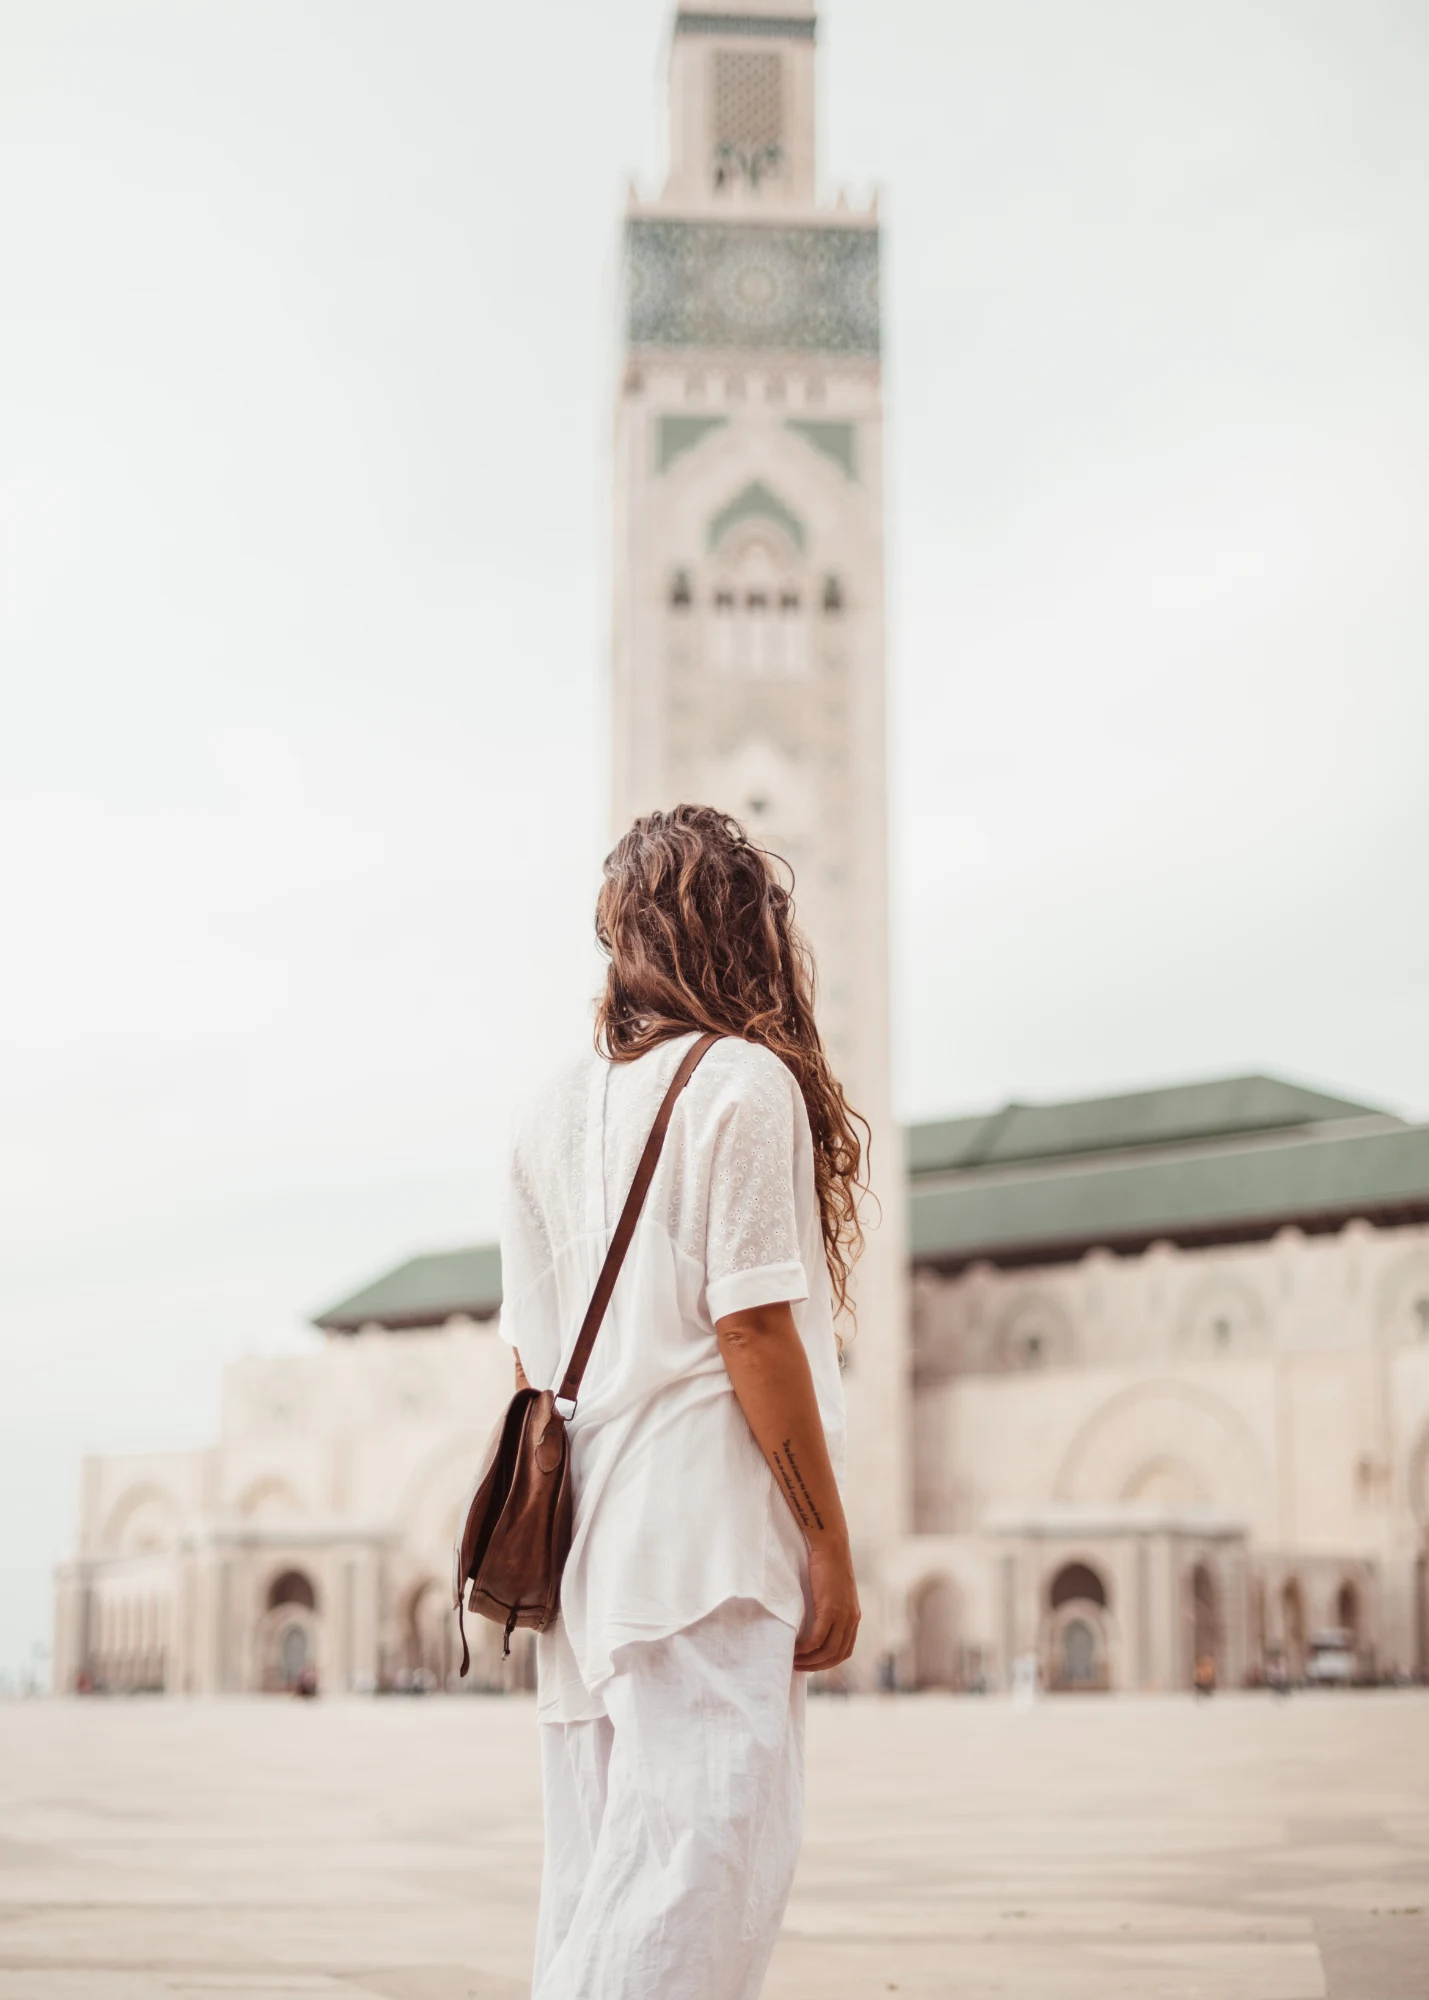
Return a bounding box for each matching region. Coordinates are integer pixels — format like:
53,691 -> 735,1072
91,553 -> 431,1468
532,1600 -> 805,2000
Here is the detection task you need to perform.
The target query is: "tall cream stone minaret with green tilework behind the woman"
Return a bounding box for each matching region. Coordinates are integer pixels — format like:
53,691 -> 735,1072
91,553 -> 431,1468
612,0 -> 909,1672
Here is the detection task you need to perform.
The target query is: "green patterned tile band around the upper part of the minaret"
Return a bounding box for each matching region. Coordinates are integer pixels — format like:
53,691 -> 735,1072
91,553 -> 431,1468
624,216 -> 879,356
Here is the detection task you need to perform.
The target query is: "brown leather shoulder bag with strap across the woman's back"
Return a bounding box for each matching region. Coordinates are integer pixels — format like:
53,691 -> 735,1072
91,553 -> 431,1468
452,1034 -> 721,1674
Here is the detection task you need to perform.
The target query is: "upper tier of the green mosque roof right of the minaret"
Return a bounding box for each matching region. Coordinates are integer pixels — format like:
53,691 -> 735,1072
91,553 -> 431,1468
907,1076 -> 1383,1176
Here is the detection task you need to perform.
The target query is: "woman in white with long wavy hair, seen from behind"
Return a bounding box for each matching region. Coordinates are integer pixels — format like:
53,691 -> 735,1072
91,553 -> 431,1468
500,806 -> 863,2000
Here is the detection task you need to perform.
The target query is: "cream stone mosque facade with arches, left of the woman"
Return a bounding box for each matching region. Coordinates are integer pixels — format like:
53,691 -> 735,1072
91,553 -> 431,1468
54,1318 -> 530,1694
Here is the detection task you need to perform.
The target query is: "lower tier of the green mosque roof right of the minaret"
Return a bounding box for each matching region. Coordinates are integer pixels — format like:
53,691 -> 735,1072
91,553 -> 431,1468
909,1126 -> 1429,1266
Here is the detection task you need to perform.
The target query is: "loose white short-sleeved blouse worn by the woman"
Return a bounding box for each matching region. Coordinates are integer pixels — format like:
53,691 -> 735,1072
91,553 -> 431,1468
500,1036 -> 845,1722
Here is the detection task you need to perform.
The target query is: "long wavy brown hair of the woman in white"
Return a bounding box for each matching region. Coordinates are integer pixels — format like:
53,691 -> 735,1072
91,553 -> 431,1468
594,806 -> 869,1312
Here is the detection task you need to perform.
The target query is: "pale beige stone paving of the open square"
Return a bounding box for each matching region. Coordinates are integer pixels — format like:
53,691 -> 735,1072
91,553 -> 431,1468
0,1692 -> 1429,2000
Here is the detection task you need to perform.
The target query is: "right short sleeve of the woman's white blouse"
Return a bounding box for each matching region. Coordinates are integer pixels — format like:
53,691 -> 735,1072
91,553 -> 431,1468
704,1048 -> 813,1320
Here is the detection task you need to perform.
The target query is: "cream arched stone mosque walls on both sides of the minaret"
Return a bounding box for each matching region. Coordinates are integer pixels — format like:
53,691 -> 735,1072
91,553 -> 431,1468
56,1224 -> 1429,1692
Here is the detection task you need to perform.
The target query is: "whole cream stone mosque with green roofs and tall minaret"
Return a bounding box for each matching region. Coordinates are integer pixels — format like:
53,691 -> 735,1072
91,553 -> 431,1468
54,0 -> 1429,1692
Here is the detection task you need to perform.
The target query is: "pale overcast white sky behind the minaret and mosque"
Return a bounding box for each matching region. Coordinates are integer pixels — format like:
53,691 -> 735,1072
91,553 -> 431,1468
0,0 -> 1429,1674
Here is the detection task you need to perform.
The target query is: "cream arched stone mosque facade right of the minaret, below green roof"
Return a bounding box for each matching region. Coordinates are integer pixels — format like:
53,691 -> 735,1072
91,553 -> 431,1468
897,1220 -> 1429,1688
